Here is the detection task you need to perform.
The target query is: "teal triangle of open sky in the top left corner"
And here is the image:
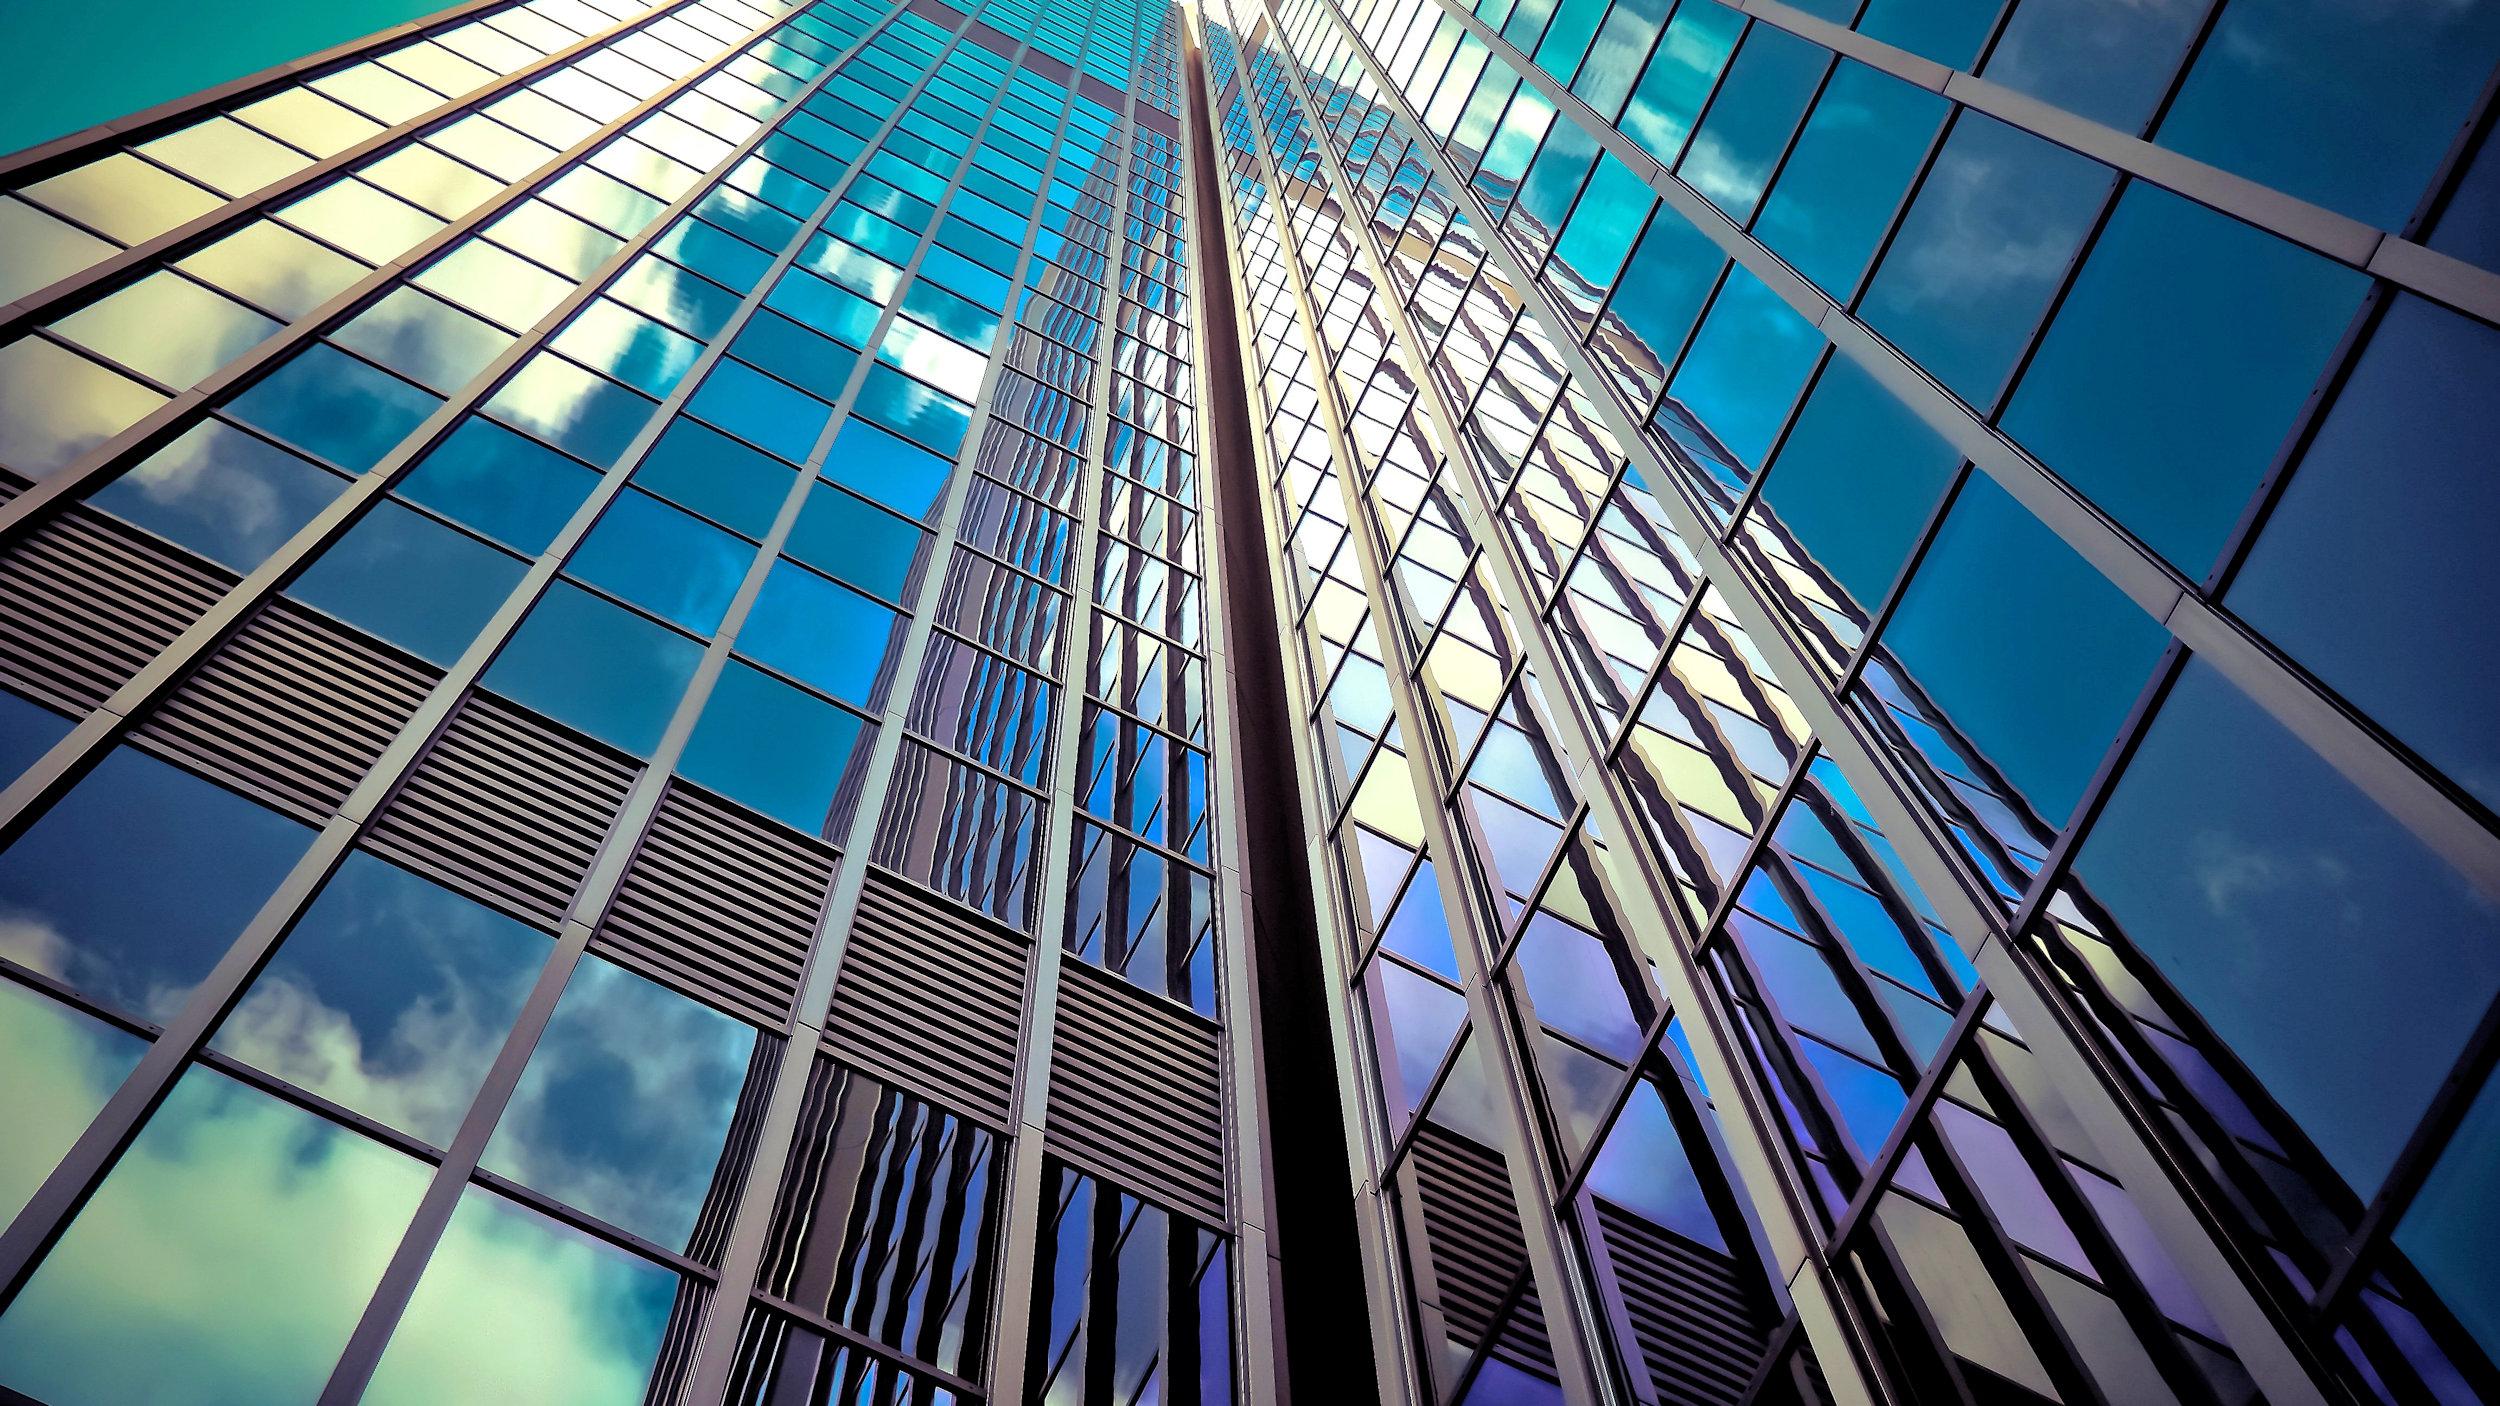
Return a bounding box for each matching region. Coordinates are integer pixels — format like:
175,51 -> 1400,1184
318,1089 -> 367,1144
0,0 -> 453,153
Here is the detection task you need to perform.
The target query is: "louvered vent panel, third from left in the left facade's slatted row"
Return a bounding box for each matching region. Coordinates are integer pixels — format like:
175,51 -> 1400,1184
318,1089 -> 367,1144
368,693 -> 635,926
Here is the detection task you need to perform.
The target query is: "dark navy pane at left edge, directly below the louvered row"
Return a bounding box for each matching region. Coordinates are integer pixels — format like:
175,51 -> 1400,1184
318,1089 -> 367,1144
0,748 -> 313,1026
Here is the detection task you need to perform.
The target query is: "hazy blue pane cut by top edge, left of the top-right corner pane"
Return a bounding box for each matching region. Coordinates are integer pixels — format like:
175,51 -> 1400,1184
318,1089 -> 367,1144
1980,0 -> 2213,135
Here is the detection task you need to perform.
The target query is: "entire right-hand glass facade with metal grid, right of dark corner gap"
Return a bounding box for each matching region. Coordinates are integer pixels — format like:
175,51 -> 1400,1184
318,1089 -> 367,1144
1208,0 -> 2500,1401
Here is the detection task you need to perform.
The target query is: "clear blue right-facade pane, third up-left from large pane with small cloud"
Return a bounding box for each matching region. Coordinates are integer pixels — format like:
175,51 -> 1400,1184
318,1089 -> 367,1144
1668,268 -> 1825,468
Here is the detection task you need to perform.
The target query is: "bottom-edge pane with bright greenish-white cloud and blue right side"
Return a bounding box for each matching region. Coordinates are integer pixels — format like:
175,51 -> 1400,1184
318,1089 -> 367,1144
358,1186 -> 680,1406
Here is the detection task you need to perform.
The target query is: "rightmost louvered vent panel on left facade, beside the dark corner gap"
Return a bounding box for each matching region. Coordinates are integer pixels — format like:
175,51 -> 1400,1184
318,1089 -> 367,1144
1048,961 -> 1225,1226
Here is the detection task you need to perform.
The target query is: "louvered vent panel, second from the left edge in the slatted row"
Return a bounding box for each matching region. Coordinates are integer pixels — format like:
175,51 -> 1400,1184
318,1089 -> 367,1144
135,600 -> 443,821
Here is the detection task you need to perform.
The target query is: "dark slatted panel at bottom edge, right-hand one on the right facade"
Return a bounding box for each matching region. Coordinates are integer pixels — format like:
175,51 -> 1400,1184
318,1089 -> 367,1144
1598,1201 -> 1768,1406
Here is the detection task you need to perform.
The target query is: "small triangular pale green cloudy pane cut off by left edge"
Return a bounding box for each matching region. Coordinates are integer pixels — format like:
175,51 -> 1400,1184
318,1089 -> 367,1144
0,981 -> 148,1221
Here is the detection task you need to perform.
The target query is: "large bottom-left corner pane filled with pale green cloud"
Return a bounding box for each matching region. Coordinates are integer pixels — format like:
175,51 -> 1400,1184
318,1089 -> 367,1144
0,1068 -> 428,1406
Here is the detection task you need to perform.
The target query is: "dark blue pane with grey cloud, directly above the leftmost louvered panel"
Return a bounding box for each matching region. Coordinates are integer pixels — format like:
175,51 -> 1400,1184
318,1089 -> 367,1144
88,420 -> 348,573
